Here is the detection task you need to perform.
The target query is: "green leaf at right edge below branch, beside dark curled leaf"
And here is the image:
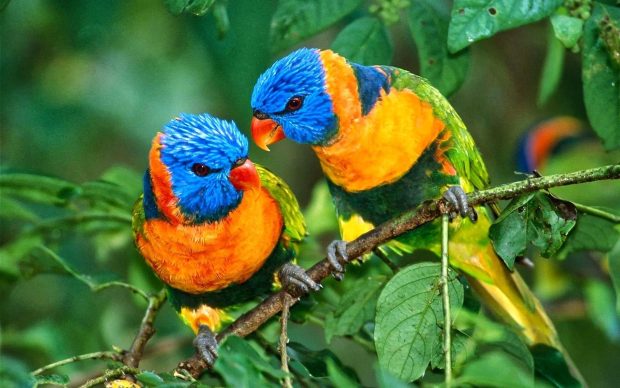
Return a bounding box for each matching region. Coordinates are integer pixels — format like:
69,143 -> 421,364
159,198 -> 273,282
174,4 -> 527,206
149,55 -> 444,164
558,213 -> 620,259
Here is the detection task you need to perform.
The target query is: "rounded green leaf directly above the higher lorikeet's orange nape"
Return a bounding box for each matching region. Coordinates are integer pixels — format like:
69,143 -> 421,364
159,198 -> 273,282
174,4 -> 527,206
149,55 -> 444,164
332,17 -> 394,65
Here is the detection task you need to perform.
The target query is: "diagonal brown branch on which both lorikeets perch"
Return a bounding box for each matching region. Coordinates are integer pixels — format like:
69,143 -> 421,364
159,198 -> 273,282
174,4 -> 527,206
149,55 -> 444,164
177,164 -> 620,377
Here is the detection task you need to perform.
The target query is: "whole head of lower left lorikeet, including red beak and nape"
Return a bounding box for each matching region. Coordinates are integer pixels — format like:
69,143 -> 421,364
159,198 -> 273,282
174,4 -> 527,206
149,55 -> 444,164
144,114 -> 260,223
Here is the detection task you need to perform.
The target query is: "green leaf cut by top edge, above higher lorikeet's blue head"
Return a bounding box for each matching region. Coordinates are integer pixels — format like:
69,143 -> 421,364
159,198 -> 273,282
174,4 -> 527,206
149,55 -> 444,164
270,0 -> 362,51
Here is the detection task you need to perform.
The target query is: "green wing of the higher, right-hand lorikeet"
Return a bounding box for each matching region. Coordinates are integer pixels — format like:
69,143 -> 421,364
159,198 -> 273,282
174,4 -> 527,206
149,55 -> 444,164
387,67 -> 489,190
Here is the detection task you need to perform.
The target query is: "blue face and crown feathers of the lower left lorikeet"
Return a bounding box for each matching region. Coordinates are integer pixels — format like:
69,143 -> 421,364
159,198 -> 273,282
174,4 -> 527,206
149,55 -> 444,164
161,114 -> 248,222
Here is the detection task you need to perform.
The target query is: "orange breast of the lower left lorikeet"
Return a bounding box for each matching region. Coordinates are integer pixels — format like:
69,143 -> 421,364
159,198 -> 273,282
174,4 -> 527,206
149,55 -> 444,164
136,189 -> 283,294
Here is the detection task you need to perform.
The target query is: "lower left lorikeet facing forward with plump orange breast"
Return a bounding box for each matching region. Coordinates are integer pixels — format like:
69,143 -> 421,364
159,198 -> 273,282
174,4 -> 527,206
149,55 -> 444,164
133,114 -> 319,364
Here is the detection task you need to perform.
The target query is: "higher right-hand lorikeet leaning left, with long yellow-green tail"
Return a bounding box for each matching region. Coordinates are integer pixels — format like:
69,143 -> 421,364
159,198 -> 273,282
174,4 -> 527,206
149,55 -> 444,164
252,48 -> 561,349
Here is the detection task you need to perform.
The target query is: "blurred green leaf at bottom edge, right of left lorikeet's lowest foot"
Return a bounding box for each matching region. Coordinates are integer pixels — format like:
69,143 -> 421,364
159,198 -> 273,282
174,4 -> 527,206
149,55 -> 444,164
214,336 -> 286,387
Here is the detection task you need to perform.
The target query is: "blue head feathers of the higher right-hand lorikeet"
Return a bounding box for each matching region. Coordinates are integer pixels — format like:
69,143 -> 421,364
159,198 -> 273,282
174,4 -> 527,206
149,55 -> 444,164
252,48 -> 337,144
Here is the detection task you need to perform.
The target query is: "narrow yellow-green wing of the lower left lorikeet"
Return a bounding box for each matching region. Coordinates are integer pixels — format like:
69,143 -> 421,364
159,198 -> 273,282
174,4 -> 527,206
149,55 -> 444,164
255,164 -> 308,242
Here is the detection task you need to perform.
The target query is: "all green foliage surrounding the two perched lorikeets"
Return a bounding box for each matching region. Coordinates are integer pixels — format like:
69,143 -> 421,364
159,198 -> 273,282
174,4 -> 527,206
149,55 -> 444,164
0,0 -> 620,387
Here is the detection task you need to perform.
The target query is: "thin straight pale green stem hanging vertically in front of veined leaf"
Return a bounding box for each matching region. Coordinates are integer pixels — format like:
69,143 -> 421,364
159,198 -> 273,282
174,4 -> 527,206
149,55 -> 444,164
440,214 -> 452,388
